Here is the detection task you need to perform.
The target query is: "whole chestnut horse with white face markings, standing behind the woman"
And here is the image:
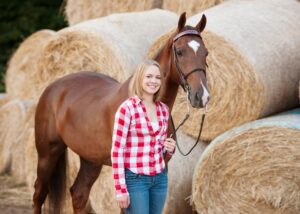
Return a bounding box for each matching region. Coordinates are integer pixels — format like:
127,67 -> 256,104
33,13 -> 209,214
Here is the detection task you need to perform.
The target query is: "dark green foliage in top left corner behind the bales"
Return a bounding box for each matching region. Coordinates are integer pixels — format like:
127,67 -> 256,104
0,0 -> 67,92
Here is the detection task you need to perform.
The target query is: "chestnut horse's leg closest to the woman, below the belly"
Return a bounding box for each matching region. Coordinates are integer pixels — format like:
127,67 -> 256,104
70,158 -> 102,214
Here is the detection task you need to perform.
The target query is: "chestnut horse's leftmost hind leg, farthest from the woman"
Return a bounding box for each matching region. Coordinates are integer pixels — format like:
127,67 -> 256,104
33,140 -> 66,214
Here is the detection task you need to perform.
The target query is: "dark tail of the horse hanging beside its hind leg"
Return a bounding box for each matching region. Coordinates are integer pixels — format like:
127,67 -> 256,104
48,149 -> 68,214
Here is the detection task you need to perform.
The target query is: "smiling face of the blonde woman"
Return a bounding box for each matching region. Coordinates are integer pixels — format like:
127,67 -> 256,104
142,65 -> 161,95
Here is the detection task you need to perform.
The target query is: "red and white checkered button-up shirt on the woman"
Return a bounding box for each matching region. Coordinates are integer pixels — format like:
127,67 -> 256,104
111,96 -> 171,197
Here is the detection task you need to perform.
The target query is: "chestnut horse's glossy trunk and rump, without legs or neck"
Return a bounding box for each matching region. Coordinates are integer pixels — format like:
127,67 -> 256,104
36,72 -> 125,162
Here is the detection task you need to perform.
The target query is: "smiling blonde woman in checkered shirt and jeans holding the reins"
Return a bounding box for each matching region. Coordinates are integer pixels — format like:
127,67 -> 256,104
111,60 -> 175,214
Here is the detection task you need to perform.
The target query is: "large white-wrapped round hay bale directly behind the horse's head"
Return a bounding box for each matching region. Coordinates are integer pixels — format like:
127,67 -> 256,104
148,0 -> 300,141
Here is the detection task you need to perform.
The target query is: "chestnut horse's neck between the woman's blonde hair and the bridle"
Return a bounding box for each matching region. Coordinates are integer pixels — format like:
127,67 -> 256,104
154,42 -> 179,111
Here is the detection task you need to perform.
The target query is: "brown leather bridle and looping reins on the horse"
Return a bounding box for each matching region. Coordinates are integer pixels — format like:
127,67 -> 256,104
170,30 -> 206,156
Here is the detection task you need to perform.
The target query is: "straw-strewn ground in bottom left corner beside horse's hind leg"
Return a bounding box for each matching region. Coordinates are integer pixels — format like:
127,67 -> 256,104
0,175 -> 32,214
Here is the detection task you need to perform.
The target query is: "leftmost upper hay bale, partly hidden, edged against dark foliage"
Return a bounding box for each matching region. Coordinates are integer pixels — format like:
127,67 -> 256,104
5,30 -> 55,99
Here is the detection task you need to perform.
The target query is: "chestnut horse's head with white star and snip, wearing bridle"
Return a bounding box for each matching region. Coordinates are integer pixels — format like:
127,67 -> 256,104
171,13 -> 209,108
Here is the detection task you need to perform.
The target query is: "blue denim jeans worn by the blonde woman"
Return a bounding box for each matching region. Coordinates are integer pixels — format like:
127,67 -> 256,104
125,169 -> 168,214
